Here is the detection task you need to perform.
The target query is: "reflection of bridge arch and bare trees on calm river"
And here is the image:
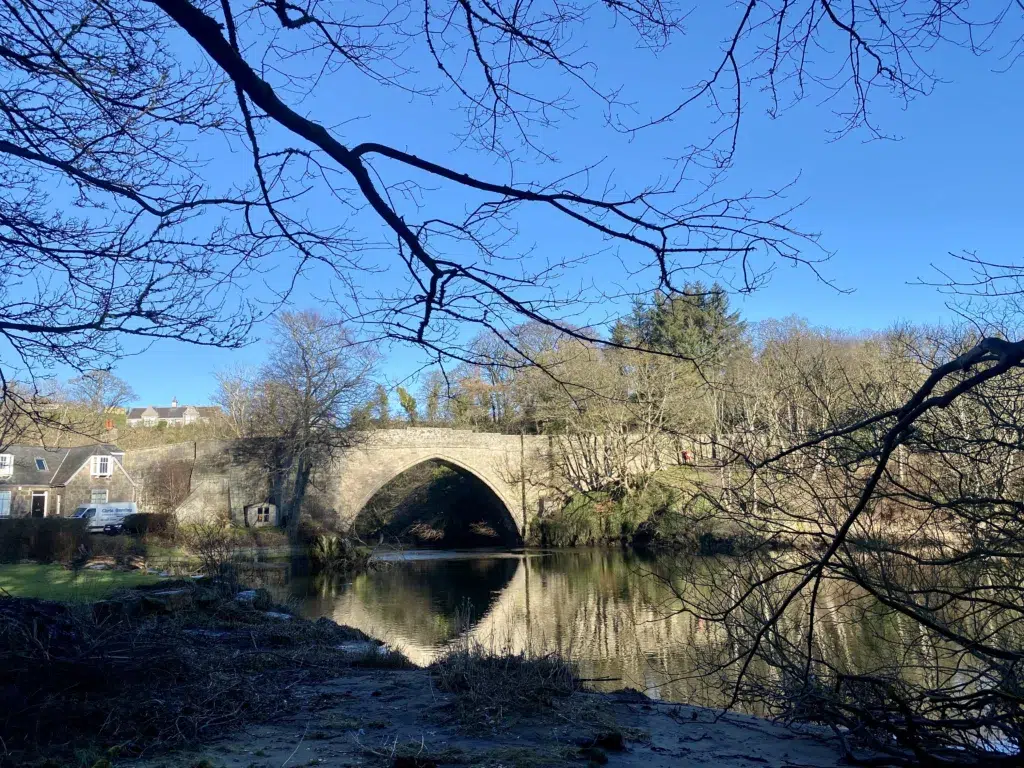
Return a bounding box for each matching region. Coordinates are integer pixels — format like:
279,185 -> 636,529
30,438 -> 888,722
294,550 -> 934,714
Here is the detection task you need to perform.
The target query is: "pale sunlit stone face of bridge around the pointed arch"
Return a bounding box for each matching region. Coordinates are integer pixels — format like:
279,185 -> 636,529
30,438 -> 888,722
322,427 -> 551,536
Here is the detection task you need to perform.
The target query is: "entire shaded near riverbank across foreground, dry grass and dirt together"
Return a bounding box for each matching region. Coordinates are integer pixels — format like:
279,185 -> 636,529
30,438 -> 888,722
0,580 -> 856,768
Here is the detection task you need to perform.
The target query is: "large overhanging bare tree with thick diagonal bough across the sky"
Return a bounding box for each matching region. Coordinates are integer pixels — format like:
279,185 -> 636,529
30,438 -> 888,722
0,0 -> 1020,444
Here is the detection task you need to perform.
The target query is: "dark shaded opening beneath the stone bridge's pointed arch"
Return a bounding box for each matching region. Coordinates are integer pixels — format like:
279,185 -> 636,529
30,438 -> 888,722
354,460 -> 521,549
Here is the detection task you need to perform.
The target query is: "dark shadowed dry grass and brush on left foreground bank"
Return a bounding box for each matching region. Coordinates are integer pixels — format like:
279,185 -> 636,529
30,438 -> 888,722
0,581 -> 408,766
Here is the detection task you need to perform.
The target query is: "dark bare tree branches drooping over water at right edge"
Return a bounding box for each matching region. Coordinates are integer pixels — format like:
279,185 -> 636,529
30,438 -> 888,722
643,325 -> 1024,765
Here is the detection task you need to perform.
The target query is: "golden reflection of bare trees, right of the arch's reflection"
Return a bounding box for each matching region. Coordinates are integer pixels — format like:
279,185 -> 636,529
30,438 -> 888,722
499,551 -> 934,714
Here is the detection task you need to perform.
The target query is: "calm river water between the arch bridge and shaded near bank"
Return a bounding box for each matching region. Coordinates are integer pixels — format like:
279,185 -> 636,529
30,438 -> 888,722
291,550 -> 888,714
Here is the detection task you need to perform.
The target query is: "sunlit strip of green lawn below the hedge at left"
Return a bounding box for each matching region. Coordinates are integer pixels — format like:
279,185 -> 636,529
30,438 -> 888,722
0,563 -> 160,602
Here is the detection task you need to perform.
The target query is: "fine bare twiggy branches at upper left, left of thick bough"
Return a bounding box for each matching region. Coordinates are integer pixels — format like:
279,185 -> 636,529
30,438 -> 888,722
0,2 -> 264,442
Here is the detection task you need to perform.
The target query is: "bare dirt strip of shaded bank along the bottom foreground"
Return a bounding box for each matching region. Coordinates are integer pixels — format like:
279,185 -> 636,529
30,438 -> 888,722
132,670 -> 856,768
